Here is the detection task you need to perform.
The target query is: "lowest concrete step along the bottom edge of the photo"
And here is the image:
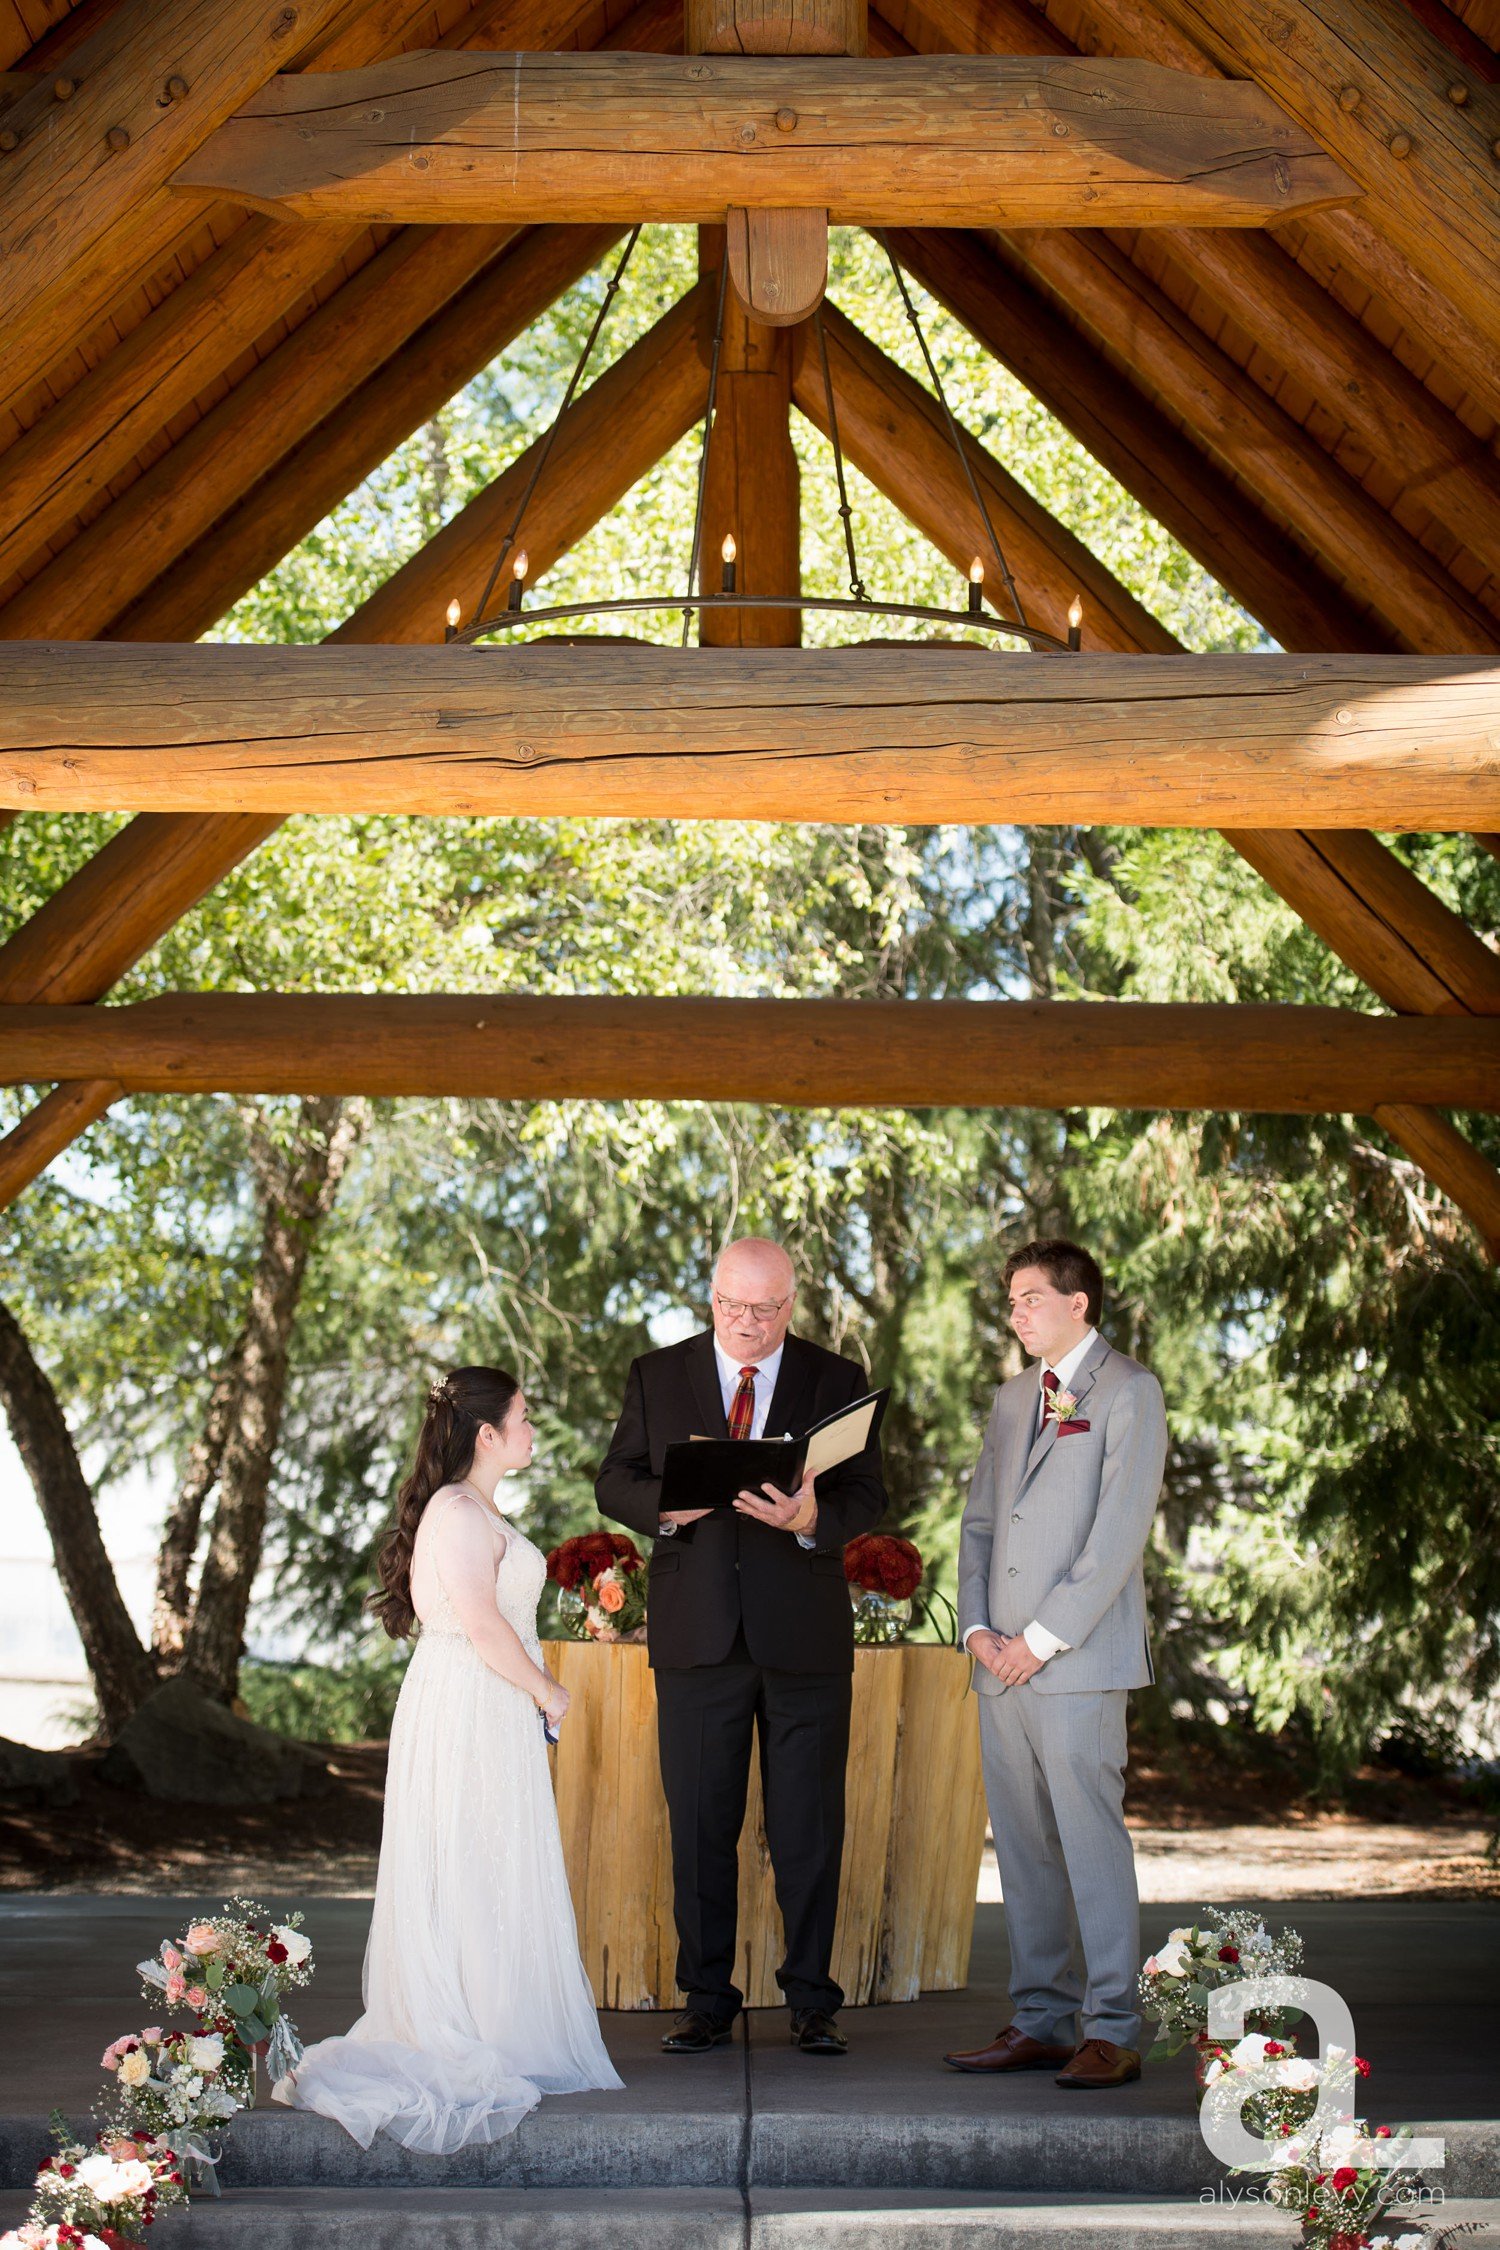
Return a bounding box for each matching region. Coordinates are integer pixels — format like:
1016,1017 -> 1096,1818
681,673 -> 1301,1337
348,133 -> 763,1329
0,2187 -> 1500,2250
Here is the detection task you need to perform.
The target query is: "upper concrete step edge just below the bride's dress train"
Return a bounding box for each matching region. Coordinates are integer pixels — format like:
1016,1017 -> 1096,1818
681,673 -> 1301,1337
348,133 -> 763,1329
0,2097 -> 1500,2201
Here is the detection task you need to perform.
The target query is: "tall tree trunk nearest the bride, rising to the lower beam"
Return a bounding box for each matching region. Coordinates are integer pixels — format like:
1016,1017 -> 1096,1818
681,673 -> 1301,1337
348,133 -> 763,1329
184,1096 -> 358,1703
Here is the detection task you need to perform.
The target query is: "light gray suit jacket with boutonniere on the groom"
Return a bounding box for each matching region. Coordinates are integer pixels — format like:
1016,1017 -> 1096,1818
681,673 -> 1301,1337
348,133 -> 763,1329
958,1337 -> 1167,1694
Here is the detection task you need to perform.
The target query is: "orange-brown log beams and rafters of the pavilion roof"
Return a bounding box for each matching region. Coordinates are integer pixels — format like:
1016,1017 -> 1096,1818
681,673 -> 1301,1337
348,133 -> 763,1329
0,0 -> 1500,1249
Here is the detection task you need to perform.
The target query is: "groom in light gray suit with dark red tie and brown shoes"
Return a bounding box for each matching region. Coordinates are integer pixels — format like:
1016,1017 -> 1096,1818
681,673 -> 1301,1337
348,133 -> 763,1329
945,1240 -> 1167,2088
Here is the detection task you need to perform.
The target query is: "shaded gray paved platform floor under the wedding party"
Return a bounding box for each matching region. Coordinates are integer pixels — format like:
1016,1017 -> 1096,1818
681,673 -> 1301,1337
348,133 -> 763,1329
0,1895 -> 1500,2122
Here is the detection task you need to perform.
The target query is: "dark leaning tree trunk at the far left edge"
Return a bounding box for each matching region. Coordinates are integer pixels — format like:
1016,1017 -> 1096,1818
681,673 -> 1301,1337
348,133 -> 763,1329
0,1303 -> 155,1735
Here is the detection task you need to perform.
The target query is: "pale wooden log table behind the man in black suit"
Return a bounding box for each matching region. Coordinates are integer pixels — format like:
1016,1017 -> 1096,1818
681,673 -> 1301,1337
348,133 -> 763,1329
546,1640 -> 985,2009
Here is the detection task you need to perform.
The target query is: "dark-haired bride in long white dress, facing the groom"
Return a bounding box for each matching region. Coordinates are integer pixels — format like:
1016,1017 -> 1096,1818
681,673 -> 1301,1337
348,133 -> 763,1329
277,1368 -> 623,2156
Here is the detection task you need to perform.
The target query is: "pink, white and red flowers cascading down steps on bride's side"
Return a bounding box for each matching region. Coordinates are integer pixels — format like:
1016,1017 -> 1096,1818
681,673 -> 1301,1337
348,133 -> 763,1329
0,1899 -> 313,2250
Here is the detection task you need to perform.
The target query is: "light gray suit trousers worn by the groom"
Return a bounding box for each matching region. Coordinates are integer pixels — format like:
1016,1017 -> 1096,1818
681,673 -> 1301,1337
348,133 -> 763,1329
978,1683 -> 1140,2048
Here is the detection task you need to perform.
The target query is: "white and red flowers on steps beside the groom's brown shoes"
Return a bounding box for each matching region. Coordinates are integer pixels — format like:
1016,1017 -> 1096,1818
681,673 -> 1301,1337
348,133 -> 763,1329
1140,1908 -> 1469,2250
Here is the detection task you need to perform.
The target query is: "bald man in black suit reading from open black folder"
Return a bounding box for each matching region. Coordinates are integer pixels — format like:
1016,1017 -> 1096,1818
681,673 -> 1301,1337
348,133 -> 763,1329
594,1235 -> 886,2054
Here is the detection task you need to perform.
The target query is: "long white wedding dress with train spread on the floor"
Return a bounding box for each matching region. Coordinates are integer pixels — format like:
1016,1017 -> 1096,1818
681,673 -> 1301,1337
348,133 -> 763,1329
277,1487 -> 623,2156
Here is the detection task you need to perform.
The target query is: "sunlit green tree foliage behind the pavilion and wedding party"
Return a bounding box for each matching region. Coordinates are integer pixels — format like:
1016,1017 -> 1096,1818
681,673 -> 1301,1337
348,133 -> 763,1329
0,230 -> 1500,1775
